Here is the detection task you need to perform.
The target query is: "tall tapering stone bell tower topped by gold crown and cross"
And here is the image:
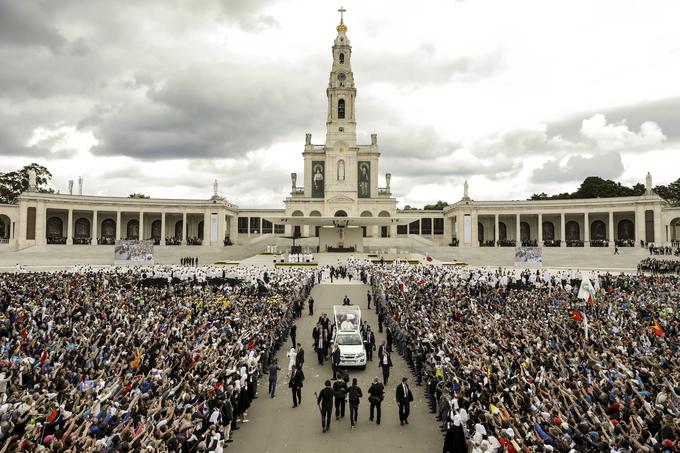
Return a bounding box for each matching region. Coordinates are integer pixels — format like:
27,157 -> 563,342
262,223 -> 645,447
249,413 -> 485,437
326,7 -> 357,147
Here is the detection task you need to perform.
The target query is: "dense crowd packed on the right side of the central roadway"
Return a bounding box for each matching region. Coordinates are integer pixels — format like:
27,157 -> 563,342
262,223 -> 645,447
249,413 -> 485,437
371,265 -> 680,453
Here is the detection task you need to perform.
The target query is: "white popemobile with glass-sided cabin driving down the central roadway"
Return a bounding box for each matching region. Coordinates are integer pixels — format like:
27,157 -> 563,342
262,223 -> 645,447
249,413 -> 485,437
333,305 -> 366,368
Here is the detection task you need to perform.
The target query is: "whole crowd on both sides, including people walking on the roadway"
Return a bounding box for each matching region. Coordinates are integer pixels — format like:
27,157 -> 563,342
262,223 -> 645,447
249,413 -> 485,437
0,258 -> 680,453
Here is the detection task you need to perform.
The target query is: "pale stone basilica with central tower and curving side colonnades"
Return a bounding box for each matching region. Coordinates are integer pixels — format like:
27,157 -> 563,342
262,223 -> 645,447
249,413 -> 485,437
0,14 -> 680,251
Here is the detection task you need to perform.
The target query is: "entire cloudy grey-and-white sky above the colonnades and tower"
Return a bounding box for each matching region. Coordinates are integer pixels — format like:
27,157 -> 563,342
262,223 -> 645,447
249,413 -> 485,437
0,0 -> 680,207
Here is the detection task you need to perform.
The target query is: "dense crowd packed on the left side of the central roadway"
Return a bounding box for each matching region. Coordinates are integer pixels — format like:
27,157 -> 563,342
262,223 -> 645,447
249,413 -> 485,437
0,266 -> 312,452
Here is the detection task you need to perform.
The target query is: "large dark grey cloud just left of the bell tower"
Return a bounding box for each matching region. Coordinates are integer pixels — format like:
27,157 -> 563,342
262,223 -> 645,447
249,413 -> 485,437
86,66 -> 324,159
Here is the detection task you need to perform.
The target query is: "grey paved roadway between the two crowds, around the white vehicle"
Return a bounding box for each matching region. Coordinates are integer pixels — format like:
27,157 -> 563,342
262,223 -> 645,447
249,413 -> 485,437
234,280 -> 444,453
